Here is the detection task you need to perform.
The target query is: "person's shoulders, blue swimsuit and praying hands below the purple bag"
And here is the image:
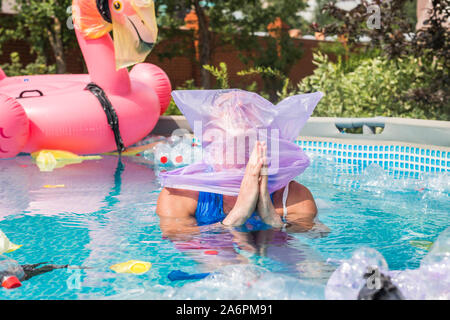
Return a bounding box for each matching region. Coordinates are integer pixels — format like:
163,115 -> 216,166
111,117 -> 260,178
156,141 -> 317,234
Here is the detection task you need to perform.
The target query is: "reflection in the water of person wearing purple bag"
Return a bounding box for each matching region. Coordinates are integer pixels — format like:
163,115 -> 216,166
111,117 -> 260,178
161,219 -> 334,281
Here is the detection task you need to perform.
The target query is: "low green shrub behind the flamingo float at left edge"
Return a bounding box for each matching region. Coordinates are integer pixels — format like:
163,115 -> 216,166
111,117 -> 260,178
0,52 -> 56,77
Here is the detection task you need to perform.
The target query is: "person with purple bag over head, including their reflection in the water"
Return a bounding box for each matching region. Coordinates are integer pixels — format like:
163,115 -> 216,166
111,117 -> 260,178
156,89 -> 329,269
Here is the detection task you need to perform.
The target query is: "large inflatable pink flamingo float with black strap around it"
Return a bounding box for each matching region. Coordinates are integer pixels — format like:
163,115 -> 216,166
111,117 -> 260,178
0,0 -> 171,158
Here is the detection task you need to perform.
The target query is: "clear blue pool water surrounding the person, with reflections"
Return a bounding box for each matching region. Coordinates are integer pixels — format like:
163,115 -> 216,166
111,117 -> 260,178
0,154 -> 450,299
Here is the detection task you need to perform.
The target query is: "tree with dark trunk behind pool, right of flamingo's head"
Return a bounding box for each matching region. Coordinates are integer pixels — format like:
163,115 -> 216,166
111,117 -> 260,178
155,0 -> 305,93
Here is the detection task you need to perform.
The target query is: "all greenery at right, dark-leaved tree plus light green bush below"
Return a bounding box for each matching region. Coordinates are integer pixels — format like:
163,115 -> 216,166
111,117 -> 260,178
308,0 -> 450,120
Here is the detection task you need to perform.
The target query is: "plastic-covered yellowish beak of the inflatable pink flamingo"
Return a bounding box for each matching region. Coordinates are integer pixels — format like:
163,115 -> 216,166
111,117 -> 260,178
112,0 -> 158,70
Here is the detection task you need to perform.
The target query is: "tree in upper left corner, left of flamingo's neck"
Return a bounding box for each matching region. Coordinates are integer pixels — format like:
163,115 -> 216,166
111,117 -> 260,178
0,0 -> 77,73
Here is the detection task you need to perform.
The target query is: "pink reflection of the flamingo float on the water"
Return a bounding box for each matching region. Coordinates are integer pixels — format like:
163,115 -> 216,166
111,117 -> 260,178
0,156 -> 155,219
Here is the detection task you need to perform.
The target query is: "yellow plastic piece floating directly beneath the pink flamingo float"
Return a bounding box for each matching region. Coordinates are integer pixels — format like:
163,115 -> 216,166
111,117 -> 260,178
31,150 -> 102,172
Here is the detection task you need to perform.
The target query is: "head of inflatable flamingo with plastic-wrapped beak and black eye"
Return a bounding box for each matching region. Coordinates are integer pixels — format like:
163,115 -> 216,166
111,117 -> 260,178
72,0 -> 158,69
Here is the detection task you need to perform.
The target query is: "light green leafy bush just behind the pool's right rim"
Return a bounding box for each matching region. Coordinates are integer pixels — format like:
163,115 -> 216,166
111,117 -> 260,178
298,52 -> 450,120
